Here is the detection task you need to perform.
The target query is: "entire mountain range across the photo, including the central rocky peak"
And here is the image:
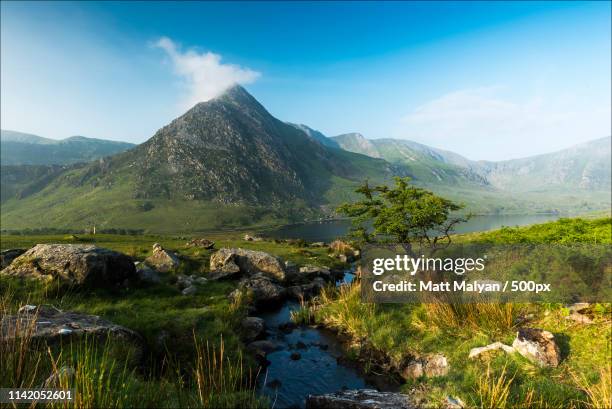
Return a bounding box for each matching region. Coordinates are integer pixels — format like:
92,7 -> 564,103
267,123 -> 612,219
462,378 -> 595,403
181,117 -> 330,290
1,86 -> 611,232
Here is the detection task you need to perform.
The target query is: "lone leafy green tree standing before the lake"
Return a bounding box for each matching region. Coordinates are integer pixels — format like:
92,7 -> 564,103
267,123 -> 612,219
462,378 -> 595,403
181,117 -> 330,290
337,177 -> 469,253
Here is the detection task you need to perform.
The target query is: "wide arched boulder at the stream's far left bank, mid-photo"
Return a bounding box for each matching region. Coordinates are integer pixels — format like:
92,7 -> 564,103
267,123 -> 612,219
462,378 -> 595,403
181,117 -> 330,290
210,248 -> 285,281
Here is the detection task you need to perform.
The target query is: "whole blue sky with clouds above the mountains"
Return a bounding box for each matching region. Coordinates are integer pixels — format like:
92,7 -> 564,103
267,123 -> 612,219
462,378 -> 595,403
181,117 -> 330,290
0,2 -> 612,160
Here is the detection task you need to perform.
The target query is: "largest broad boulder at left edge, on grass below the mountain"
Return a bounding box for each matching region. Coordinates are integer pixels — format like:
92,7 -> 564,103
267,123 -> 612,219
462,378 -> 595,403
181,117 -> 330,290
2,244 -> 137,287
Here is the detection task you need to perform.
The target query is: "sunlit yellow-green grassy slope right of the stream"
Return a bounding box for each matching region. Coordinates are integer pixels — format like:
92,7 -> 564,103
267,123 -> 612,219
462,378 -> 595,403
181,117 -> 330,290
306,218 -> 612,408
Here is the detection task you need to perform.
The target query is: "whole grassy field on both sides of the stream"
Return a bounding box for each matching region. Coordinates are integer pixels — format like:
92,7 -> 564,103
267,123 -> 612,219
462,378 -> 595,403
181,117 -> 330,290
0,218 -> 612,408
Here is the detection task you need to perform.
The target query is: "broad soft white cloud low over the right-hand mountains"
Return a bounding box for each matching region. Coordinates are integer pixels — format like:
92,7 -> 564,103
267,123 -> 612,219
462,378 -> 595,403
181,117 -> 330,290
399,86 -> 611,160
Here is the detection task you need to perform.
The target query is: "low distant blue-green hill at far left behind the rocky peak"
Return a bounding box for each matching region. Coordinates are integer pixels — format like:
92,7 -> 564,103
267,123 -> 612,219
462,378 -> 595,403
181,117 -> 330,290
0,129 -> 134,165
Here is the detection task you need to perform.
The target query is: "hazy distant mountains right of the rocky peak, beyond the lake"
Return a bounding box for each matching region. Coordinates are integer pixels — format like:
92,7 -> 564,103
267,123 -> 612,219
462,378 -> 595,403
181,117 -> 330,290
332,133 -> 612,213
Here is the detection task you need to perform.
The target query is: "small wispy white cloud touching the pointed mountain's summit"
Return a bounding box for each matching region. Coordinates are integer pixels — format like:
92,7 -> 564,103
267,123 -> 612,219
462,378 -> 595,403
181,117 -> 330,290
154,37 -> 261,107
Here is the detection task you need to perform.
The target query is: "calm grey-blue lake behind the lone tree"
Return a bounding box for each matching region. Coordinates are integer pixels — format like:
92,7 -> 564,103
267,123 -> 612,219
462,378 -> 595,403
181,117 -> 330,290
263,214 -> 560,242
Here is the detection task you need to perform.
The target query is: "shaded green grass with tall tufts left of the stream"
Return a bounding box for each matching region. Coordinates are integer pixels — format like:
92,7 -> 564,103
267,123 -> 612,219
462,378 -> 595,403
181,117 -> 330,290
0,233 -> 346,408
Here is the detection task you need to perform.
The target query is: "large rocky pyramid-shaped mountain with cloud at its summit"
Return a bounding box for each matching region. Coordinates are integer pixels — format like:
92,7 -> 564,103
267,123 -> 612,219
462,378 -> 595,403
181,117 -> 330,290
1,86 -> 396,231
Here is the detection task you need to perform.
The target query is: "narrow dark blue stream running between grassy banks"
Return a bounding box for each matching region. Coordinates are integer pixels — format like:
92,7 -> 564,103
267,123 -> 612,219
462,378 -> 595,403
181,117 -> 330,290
258,272 -> 389,408
